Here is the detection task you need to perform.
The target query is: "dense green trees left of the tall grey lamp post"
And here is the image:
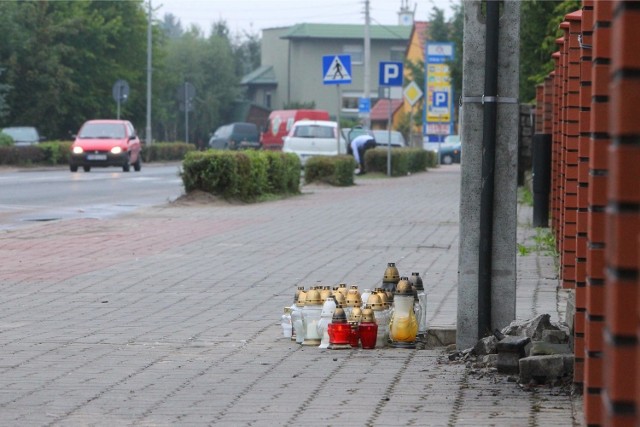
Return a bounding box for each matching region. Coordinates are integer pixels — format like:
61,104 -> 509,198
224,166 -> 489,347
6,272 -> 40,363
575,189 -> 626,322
0,0 -> 146,138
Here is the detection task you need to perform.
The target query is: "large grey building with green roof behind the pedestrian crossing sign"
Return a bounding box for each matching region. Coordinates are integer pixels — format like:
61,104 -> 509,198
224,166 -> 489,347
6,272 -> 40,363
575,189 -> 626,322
242,23 -> 412,118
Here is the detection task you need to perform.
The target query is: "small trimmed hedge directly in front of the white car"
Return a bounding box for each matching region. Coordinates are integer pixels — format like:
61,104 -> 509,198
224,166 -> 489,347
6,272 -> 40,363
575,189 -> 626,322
304,155 -> 357,187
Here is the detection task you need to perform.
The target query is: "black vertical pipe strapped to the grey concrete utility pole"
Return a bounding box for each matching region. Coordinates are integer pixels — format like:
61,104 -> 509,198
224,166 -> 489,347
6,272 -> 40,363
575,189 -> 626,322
478,0 -> 500,338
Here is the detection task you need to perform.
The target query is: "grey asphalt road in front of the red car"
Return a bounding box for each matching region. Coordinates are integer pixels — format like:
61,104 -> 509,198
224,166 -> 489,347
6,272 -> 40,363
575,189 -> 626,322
0,163 -> 184,230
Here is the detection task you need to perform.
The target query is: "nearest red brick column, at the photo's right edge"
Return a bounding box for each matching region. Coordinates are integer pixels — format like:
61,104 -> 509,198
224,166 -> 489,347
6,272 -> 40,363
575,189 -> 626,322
598,1 -> 640,426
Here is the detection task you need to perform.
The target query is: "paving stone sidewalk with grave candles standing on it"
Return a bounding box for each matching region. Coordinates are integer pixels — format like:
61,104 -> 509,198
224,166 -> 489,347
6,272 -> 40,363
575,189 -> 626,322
0,165 -> 582,426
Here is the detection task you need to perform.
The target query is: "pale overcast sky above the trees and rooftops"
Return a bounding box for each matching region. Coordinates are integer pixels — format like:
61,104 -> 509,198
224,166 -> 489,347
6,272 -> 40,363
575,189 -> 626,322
151,0 -> 452,34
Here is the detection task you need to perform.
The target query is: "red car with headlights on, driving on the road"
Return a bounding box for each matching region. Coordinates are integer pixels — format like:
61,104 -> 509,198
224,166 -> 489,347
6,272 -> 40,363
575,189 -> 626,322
69,120 -> 141,172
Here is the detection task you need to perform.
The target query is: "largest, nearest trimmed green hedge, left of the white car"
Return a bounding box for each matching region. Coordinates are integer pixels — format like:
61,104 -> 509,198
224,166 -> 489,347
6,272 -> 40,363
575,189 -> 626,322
182,150 -> 300,201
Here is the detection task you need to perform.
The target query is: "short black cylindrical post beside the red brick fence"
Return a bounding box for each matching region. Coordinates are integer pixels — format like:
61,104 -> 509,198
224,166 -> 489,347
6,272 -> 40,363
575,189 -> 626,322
531,133 -> 551,228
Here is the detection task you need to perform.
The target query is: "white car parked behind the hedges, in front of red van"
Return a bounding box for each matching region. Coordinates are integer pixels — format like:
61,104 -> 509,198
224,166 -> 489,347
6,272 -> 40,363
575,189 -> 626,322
282,120 -> 347,166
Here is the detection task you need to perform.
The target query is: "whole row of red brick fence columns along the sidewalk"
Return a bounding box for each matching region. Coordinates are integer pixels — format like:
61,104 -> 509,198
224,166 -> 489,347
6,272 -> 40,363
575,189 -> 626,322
536,0 -> 640,427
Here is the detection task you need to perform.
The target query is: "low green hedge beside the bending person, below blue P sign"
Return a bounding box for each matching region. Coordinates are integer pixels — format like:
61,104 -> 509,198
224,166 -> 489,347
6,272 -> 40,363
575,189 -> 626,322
364,147 -> 437,176
